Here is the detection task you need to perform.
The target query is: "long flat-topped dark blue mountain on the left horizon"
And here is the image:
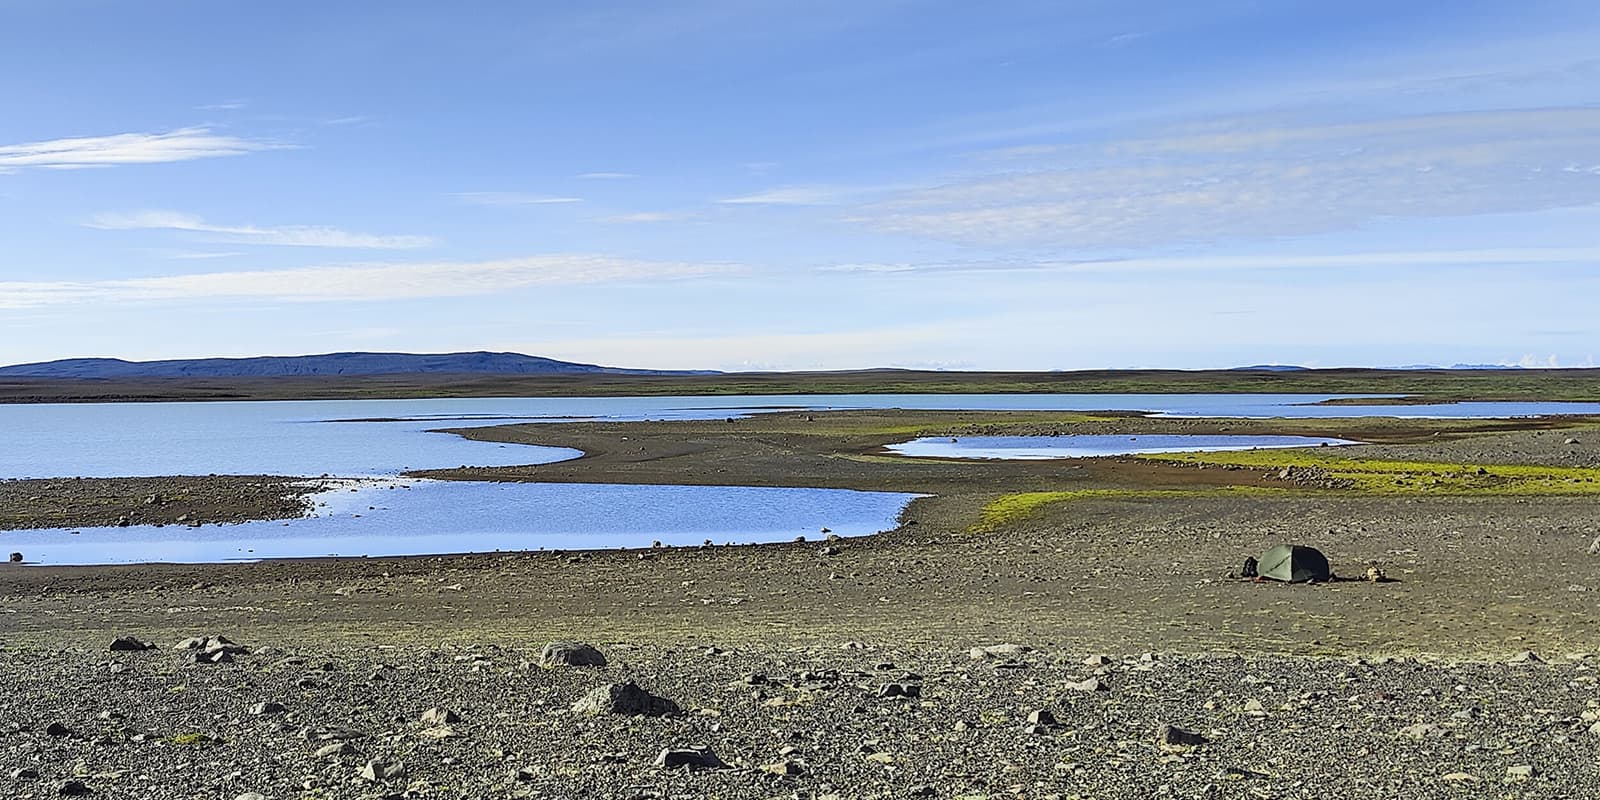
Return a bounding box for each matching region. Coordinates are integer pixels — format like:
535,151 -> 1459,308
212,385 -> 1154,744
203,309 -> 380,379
0,350 -> 717,379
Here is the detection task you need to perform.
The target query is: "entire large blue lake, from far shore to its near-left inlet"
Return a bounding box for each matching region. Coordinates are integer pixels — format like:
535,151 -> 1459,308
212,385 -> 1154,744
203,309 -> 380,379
0,394 -> 1600,563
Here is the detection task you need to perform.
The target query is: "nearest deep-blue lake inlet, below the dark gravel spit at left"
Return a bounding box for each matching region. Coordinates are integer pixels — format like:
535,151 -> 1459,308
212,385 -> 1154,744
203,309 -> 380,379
0,480 -> 915,565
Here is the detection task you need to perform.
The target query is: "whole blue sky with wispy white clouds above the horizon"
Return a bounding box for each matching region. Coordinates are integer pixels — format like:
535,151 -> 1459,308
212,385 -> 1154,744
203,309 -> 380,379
0,0 -> 1600,370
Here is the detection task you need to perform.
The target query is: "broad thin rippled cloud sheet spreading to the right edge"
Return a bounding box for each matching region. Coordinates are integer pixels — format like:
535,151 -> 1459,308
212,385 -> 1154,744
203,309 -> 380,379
853,109 -> 1600,248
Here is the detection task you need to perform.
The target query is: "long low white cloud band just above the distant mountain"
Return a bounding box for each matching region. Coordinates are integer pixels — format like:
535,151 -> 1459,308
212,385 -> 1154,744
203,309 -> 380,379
0,254 -> 741,309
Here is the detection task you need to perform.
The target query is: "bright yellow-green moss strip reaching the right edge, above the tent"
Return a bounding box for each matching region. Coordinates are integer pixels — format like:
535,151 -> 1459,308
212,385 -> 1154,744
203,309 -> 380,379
1139,450 -> 1600,496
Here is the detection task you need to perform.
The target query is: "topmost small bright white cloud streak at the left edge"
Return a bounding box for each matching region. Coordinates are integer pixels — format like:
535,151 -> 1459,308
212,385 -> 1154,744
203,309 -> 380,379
0,128 -> 284,170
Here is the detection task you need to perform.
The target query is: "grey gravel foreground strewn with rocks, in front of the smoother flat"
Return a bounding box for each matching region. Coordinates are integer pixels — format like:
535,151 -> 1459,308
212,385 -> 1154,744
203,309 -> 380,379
0,630 -> 1600,800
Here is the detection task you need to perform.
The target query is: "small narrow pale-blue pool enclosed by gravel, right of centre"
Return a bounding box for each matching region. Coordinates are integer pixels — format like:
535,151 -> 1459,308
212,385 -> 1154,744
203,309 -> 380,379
886,434 -> 1357,461
